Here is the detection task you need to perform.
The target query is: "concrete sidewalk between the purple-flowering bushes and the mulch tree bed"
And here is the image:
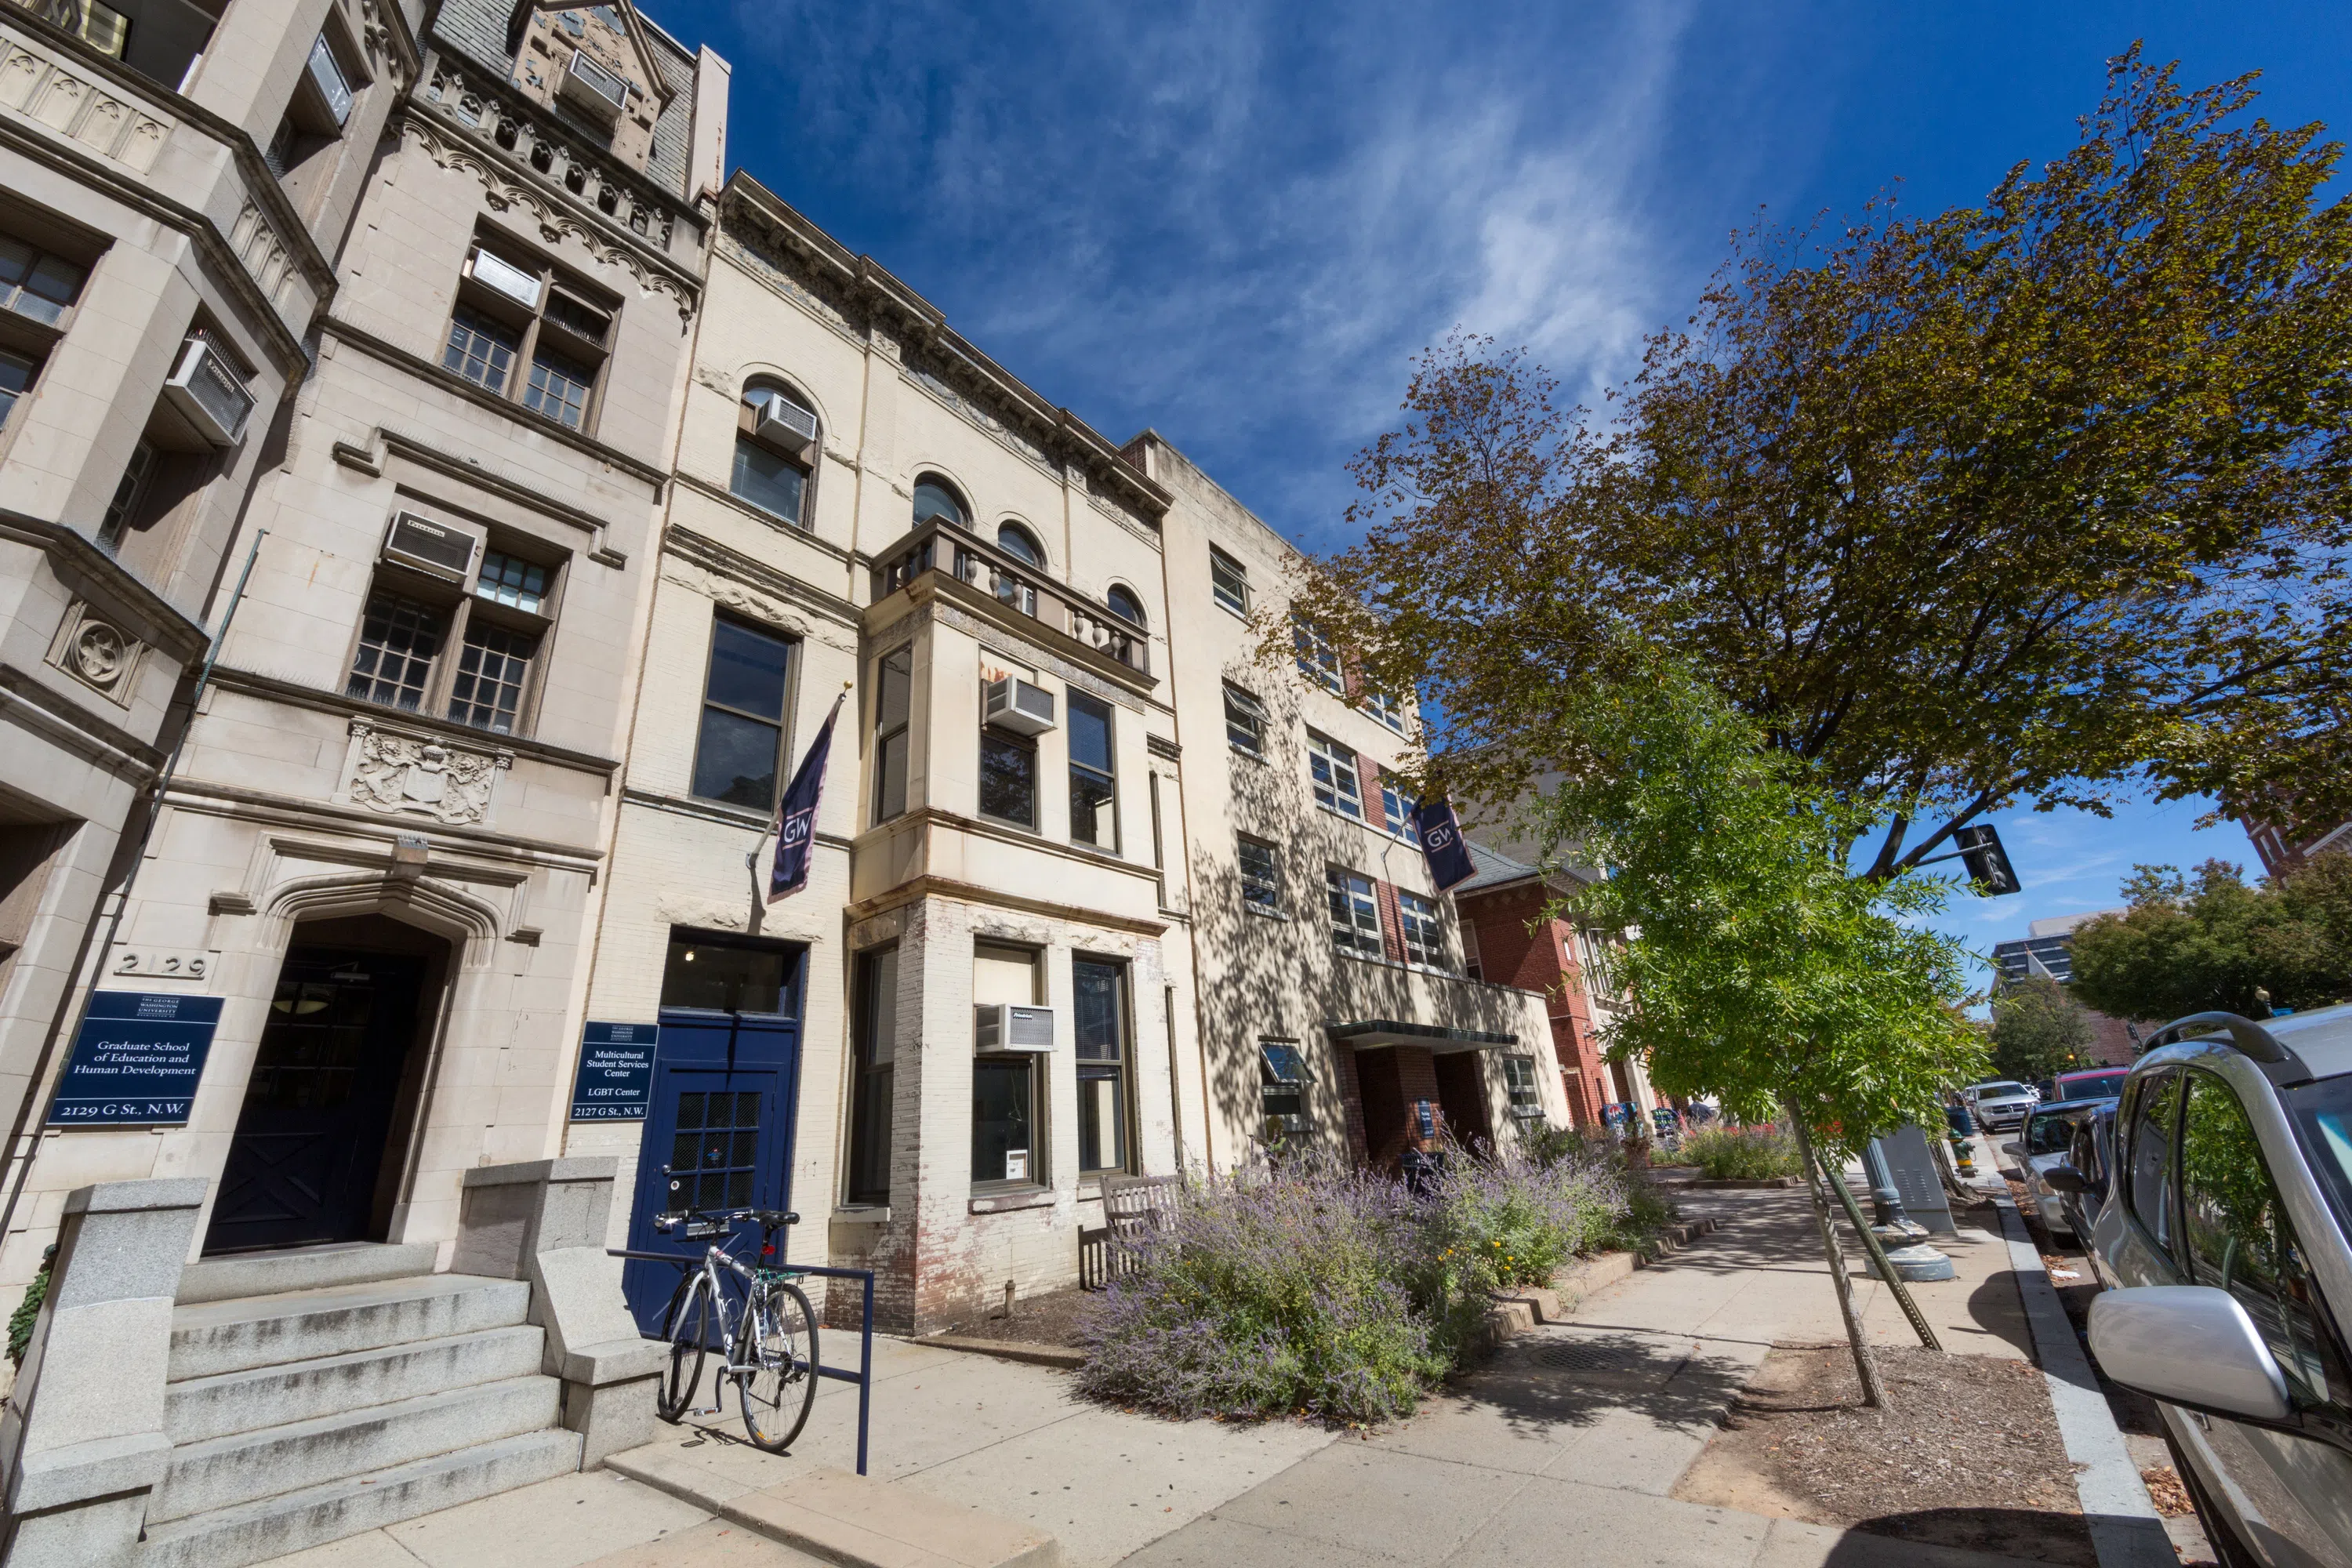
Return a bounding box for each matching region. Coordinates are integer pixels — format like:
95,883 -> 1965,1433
1129,1189 -> 2060,1568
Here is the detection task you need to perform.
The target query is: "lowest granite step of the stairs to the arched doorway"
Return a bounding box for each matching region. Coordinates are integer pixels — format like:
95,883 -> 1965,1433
139,1429 -> 581,1568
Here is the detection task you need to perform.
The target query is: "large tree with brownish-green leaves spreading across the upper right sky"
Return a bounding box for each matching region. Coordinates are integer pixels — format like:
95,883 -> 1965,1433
1291,49 -> 2352,879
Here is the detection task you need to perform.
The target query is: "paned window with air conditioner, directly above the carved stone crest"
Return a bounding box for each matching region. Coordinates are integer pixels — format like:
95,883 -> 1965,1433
346,514 -> 560,736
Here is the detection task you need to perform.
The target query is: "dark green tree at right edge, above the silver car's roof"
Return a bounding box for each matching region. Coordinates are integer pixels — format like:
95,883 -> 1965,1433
2074,851 -> 2352,1020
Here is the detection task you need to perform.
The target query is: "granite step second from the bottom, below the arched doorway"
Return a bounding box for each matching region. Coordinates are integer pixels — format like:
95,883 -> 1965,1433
148,1375 -> 562,1528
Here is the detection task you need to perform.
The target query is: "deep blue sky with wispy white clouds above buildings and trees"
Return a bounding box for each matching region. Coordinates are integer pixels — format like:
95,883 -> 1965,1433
652,0 -> 2352,968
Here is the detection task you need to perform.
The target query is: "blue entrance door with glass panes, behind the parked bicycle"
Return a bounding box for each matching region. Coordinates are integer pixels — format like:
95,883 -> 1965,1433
621,1006 -> 800,1333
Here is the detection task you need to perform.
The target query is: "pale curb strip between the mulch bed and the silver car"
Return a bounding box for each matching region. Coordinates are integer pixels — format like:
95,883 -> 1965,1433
1992,1194 -> 2180,1568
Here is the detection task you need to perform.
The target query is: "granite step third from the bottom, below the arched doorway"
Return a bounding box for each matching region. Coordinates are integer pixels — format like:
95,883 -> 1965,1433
162,1323 -> 546,1443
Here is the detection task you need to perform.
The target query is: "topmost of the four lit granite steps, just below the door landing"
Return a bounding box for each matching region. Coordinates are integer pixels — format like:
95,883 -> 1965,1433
169,1274 -> 532,1382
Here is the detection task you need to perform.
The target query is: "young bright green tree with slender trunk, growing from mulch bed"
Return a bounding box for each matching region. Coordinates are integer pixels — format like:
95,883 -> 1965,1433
1545,661 -> 1983,1403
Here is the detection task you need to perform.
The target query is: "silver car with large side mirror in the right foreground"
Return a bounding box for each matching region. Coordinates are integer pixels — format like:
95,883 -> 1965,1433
2058,1006 -> 2352,1568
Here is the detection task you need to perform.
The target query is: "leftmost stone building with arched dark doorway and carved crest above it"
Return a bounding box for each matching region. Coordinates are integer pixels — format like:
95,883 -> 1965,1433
0,0 -> 727,1286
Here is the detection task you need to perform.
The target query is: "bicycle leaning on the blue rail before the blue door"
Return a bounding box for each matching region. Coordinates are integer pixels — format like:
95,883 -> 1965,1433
654,1208 -> 816,1453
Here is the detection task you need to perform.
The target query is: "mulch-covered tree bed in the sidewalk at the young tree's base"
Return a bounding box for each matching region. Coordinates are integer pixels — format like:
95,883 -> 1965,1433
1675,1345 -> 2098,1568
